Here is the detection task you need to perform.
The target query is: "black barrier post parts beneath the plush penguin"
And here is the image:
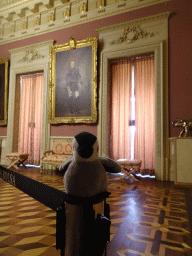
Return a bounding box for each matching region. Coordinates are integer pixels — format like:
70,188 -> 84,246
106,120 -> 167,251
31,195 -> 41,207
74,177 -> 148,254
56,192 -> 111,256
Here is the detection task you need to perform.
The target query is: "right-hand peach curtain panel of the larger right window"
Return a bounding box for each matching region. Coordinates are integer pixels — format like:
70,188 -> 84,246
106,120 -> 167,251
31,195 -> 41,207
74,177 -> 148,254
134,57 -> 155,174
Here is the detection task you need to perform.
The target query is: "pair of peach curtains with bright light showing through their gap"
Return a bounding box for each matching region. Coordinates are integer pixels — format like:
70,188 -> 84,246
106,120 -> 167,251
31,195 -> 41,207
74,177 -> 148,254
111,55 -> 155,174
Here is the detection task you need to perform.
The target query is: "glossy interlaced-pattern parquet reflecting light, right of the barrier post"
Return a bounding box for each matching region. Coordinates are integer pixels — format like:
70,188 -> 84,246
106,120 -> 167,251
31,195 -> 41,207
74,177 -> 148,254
108,178 -> 192,256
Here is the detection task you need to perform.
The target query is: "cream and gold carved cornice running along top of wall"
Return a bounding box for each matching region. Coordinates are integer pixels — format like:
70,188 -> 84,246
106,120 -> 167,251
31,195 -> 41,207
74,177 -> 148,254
0,0 -> 170,45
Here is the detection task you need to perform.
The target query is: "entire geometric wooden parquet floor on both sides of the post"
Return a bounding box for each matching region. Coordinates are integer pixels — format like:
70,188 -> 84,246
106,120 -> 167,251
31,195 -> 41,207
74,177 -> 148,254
0,168 -> 192,256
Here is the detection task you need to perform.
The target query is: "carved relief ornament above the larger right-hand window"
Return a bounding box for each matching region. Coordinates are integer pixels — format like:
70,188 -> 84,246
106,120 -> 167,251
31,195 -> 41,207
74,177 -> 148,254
111,25 -> 154,45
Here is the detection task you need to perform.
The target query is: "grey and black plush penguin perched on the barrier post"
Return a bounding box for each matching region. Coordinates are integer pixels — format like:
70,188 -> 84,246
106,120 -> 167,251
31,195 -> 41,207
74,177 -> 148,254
59,132 -> 121,197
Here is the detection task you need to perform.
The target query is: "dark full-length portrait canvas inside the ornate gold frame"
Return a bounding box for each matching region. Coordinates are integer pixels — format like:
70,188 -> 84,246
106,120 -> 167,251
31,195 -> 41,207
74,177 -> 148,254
55,45 -> 92,118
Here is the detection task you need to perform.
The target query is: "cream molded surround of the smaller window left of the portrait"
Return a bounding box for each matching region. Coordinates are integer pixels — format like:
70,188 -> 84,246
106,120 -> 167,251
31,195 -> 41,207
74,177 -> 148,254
6,40 -> 54,164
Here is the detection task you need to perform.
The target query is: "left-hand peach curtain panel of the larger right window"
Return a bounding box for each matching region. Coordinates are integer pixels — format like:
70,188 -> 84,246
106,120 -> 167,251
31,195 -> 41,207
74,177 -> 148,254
111,60 -> 132,160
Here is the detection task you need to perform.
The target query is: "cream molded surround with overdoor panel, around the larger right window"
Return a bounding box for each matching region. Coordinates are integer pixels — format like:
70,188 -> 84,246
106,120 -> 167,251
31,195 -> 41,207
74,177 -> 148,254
98,12 -> 170,180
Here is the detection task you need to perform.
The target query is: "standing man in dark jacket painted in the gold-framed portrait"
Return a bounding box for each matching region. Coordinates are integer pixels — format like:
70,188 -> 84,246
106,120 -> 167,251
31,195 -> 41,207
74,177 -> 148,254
66,61 -> 82,114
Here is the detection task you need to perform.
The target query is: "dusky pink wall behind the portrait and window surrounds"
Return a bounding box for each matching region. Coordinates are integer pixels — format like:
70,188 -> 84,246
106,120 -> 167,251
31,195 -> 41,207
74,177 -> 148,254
0,0 -> 192,137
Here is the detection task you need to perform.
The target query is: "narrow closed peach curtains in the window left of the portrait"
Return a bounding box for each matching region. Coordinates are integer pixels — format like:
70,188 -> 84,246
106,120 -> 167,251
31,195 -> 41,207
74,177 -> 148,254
18,74 -> 43,165
